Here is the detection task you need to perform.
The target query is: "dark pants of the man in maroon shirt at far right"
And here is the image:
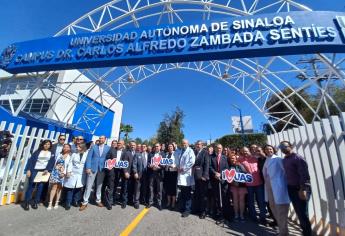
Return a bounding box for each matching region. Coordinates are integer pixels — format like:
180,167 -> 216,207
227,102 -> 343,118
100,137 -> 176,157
288,185 -> 312,236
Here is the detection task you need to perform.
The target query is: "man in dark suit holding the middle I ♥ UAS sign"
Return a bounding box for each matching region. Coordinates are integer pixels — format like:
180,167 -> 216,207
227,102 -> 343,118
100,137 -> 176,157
146,143 -> 165,210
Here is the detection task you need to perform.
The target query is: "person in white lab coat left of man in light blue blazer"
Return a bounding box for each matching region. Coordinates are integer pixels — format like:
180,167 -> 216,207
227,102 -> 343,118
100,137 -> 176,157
64,143 -> 88,210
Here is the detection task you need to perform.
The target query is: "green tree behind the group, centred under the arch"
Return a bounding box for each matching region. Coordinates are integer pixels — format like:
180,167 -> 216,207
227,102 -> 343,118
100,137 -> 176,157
157,107 -> 185,144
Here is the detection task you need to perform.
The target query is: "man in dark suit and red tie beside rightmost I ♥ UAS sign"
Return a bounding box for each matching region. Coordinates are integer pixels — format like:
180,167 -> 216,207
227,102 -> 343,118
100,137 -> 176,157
210,144 -> 229,221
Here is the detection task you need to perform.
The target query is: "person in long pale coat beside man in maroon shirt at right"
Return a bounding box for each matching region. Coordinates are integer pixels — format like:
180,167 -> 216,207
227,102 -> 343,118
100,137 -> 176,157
262,145 -> 290,235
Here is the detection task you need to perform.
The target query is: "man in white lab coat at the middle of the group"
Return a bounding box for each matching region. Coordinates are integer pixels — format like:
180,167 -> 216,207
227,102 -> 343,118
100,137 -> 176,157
177,139 -> 195,217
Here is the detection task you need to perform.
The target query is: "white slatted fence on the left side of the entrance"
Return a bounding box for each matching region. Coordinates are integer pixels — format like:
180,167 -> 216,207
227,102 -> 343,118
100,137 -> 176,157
0,121 -> 68,205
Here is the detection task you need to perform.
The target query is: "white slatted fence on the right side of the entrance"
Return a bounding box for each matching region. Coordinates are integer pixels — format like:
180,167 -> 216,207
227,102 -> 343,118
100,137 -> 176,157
267,113 -> 345,235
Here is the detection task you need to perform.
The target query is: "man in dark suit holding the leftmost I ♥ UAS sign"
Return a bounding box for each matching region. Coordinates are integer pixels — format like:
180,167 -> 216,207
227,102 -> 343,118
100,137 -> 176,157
106,140 -> 128,210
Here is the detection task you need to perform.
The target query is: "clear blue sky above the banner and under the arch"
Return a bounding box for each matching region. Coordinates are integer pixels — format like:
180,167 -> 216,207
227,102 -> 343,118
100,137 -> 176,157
0,0 -> 345,142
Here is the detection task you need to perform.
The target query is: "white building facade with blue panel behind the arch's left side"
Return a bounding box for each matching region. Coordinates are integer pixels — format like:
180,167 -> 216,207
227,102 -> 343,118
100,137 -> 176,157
0,70 -> 123,139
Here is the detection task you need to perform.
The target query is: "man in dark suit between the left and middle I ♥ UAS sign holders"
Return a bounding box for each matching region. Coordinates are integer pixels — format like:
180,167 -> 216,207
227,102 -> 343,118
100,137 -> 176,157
132,144 -> 148,209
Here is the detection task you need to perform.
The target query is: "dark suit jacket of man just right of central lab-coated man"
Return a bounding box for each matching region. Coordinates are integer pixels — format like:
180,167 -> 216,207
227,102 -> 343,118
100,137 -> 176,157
193,149 -> 210,180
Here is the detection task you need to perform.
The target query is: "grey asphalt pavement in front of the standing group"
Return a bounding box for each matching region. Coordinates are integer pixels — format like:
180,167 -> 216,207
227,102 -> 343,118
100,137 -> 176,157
0,205 -> 300,236
